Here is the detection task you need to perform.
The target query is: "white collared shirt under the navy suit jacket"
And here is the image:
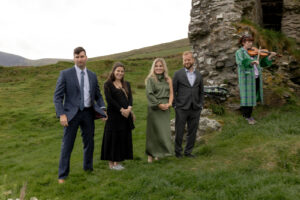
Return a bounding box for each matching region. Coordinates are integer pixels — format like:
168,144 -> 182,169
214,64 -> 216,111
75,65 -> 92,108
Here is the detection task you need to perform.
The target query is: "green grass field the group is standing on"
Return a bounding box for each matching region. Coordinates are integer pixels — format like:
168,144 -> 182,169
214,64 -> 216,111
0,57 -> 300,200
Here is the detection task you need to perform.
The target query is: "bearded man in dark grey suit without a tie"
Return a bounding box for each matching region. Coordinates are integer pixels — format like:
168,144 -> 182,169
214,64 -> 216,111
173,51 -> 204,158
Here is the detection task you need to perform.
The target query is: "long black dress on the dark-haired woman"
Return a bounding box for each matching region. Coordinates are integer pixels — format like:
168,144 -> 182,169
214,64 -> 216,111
101,81 -> 134,162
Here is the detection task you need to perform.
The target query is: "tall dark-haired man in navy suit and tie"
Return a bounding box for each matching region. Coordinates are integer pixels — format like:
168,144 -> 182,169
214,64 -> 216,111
53,47 -> 106,183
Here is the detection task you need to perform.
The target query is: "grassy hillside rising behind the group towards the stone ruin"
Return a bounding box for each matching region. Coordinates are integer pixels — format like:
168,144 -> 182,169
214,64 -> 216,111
89,38 -> 191,61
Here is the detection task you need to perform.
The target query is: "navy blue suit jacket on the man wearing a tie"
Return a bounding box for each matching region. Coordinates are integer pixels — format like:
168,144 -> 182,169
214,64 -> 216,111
53,67 -> 105,121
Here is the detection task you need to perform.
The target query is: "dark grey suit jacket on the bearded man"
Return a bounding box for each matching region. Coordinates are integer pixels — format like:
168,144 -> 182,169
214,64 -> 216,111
173,68 -> 204,110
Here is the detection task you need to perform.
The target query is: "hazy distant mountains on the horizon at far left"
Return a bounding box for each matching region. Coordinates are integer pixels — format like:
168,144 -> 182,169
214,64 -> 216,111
0,51 -> 69,66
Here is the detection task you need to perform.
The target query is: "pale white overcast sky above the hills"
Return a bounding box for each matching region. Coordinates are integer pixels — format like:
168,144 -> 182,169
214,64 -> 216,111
0,0 -> 191,59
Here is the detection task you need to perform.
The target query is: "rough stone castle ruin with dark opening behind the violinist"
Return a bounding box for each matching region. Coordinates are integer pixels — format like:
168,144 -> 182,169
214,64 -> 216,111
189,0 -> 300,103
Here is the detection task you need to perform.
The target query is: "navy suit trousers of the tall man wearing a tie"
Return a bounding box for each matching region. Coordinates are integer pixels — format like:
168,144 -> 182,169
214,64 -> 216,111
58,108 -> 95,179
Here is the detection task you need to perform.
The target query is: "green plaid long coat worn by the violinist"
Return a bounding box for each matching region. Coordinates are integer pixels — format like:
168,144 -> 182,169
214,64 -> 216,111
235,47 -> 272,106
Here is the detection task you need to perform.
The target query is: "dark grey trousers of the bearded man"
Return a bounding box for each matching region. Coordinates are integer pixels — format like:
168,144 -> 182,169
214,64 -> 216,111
175,109 -> 201,155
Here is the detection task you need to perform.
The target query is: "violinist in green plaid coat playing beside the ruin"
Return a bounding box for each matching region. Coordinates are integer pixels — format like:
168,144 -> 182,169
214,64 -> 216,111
235,35 -> 276,125
